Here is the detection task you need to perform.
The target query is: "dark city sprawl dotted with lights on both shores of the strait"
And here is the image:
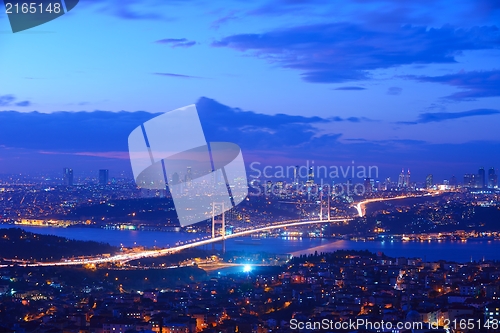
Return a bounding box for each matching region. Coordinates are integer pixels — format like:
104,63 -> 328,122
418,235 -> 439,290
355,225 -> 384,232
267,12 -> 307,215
0,168 -> 500,333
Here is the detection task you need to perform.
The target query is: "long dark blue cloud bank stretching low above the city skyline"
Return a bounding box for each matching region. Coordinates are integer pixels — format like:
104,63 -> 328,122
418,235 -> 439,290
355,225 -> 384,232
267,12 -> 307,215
0,98 -> 500,178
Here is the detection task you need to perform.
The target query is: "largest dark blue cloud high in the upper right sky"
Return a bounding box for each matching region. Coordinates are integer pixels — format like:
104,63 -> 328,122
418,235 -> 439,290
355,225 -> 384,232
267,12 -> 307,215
212,23 -> 500,83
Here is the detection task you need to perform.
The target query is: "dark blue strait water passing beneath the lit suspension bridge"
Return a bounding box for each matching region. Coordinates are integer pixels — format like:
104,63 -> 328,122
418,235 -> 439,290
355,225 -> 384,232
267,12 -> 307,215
0,225 -> 500,262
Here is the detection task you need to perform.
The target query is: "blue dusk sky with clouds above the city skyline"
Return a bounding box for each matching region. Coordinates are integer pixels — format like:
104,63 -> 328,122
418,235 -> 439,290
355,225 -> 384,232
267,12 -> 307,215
0,0 -> 500,181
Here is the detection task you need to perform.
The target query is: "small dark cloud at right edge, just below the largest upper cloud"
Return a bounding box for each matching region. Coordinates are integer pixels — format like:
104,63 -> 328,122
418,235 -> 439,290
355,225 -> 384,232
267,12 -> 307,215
406,70 -> 500,101
